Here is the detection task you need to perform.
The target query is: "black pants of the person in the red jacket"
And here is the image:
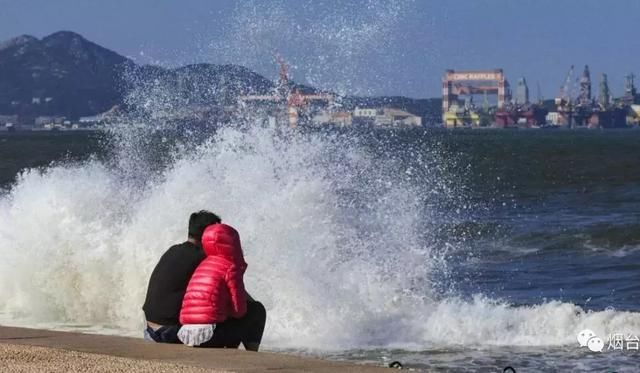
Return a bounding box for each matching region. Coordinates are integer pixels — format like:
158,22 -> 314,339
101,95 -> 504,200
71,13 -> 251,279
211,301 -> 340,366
200,301 -> 267,348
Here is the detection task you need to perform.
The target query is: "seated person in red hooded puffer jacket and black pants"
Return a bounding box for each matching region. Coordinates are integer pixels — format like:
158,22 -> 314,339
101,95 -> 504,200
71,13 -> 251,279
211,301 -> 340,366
178,224 -> 266,351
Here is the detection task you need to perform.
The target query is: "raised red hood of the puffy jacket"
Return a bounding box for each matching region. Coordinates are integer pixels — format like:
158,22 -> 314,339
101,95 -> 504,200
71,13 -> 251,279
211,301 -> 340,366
202,224 -> 247,268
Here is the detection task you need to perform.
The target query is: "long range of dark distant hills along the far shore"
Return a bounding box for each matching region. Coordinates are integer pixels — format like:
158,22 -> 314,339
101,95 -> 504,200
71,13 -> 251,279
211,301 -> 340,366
0,31 -> 440,122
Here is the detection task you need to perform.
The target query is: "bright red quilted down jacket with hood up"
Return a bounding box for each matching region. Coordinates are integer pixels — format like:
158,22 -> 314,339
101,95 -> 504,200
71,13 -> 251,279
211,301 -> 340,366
180,224 -> 247,325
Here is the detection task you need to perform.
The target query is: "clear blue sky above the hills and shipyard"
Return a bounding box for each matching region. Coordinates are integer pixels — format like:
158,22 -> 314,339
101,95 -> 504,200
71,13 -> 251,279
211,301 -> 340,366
0,0 -> 640,98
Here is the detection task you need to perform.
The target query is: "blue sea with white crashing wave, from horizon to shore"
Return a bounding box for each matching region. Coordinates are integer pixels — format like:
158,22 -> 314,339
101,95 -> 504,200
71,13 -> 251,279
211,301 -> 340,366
0,125 -> 640,372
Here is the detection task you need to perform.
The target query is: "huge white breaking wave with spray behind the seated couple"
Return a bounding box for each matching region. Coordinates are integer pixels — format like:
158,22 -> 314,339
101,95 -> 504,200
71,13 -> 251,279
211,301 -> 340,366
0,126 -> 640,350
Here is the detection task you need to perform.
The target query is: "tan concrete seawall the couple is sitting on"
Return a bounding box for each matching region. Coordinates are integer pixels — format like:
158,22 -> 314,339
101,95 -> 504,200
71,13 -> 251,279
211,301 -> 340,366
0,326 -> 390,373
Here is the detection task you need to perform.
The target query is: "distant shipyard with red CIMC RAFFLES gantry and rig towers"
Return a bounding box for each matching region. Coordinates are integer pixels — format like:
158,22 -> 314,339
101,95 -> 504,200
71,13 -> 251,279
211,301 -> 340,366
442,66 -> 640,128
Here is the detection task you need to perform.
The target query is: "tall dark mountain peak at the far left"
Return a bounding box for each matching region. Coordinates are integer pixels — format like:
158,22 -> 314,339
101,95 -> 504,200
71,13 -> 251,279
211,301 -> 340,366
0,31 -> 133,117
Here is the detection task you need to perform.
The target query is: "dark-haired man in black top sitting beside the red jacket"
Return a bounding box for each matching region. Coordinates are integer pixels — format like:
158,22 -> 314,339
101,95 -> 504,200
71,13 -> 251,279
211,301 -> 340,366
142,210 -> 221,343
